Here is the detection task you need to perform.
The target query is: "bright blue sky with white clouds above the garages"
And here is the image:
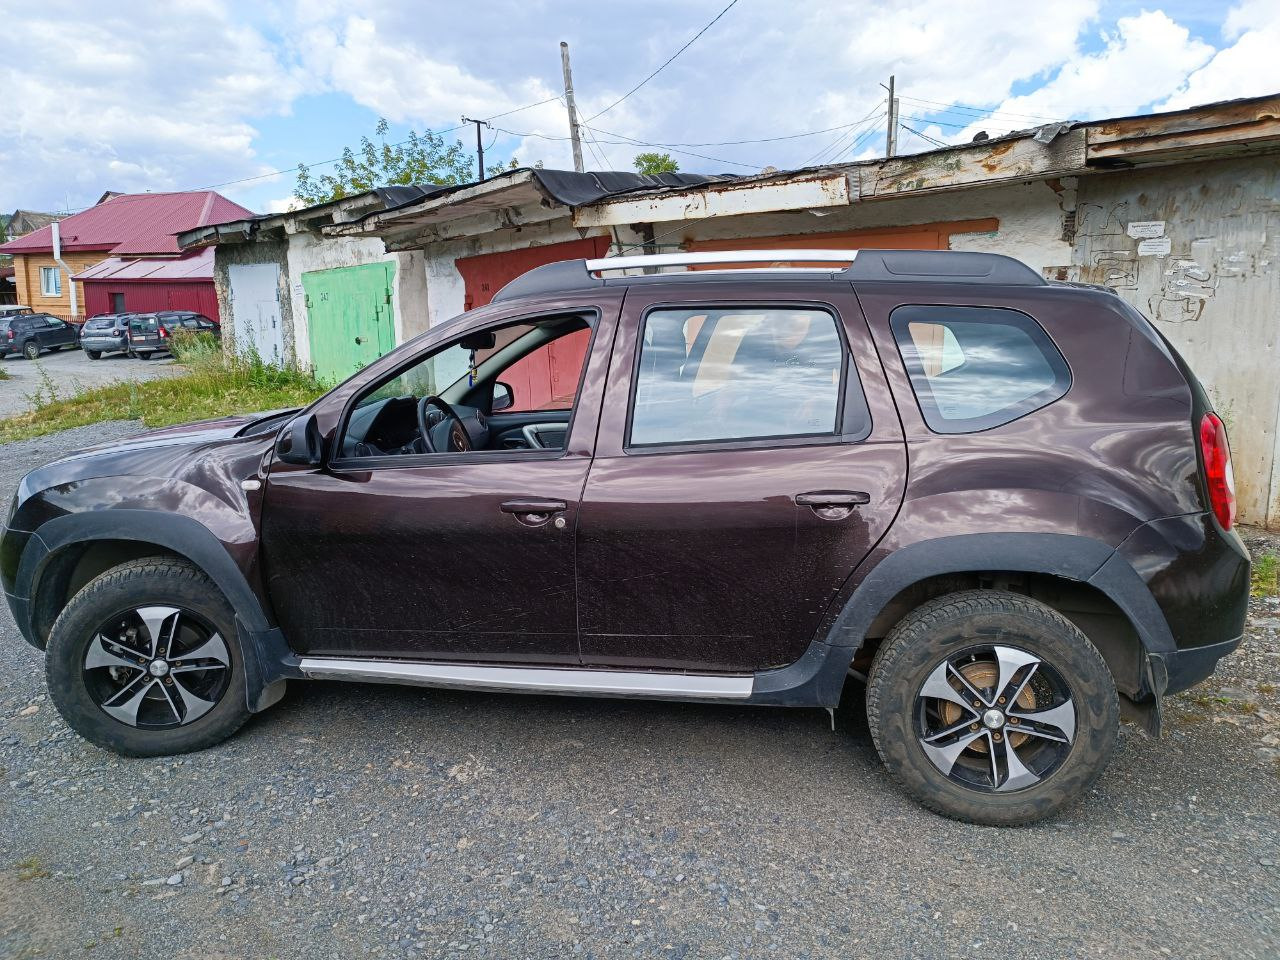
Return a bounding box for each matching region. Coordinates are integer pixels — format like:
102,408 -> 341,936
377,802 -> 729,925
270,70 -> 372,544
0,0 -> 1280,212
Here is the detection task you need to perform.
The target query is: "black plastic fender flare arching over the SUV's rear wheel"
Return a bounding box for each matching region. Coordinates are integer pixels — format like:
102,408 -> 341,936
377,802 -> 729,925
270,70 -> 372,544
748,534 -> 1175,707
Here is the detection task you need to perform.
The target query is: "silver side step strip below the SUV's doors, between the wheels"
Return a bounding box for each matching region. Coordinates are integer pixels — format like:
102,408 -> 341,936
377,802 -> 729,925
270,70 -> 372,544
298,657 -> 754,700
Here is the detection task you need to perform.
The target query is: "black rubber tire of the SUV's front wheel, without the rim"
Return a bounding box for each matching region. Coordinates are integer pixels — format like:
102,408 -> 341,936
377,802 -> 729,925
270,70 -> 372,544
45,557 -> 250,756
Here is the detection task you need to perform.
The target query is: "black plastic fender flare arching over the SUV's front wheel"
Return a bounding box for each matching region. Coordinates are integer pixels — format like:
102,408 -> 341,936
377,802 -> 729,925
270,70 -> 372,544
14,509 -> 301,712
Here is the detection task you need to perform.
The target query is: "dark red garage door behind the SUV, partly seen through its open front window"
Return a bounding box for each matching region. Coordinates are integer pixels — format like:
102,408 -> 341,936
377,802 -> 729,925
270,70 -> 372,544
454,237 -> 609,410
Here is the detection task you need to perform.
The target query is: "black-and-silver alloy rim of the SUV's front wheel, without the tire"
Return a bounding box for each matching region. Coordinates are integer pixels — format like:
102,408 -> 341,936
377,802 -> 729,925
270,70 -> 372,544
82,607 -> 232,730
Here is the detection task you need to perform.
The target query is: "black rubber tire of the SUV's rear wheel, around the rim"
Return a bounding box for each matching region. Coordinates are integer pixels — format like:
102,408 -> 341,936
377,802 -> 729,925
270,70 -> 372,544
867,590 -> 1120,826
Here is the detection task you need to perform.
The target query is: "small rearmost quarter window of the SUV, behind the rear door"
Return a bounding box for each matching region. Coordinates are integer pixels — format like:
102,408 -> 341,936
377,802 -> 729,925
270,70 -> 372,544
890,306 -> 1071,434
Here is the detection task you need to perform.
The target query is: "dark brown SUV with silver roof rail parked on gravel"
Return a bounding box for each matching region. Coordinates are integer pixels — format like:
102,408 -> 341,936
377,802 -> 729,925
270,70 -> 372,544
0,251 -> 1249,823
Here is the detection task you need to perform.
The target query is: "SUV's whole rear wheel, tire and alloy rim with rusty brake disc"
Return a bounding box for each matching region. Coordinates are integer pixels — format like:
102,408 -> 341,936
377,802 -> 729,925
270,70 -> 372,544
867,590 -> 1120,826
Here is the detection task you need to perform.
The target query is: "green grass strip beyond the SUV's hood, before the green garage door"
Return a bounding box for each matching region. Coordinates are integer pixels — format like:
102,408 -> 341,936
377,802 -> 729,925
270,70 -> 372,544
0,334 -> 328,443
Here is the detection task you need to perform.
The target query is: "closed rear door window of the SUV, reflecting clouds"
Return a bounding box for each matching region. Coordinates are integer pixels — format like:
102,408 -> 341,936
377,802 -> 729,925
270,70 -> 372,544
628,307 -> 846,447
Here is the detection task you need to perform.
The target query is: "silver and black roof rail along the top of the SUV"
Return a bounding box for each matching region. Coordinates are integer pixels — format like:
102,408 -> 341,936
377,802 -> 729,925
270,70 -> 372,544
493,248 -> 1047,302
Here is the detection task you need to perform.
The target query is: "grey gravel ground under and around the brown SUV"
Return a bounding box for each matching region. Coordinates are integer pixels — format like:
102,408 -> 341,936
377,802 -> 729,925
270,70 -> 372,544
0,424 -> 1280,960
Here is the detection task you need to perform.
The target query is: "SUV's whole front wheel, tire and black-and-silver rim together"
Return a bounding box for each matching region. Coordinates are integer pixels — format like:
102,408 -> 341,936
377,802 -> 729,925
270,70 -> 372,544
45,557 -> 250,756
